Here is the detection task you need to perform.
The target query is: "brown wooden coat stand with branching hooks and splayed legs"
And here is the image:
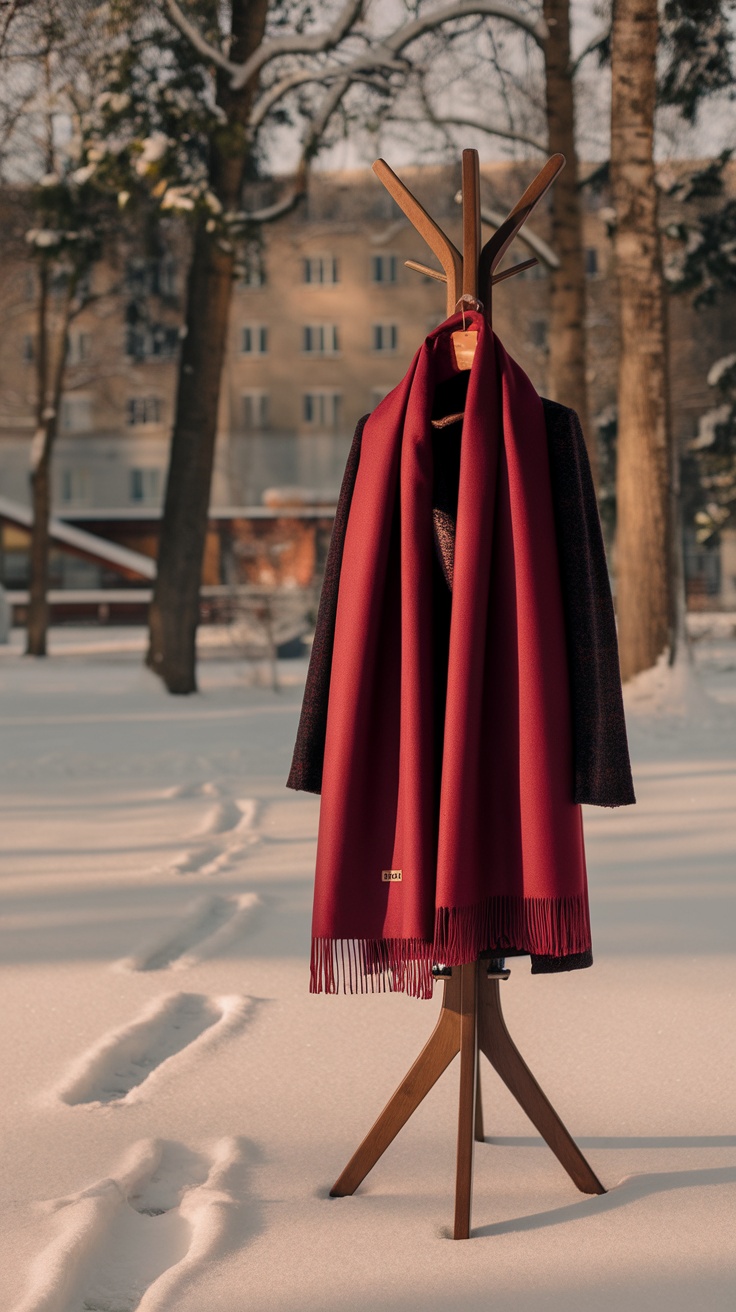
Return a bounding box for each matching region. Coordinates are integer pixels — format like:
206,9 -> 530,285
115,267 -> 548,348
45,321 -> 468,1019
331,150 -> 605,1239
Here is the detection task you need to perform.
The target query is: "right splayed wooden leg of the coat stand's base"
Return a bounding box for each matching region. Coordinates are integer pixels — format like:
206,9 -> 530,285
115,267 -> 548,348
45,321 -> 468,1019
478,968 -> 606,1194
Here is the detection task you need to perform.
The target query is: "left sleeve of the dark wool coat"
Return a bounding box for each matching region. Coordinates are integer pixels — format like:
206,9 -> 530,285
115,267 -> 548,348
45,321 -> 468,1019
286,415 -> 367,792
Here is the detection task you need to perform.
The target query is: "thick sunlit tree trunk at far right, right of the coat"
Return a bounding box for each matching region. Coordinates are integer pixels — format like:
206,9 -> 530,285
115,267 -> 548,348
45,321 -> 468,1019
611,0 -> 672,680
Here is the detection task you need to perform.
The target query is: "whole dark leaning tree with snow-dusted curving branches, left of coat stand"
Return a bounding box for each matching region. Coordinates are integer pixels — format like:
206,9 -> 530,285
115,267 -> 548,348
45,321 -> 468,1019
139,0 -> 544,693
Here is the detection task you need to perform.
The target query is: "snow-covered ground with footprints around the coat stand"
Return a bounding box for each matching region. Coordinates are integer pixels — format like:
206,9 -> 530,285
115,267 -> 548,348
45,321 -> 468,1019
0,618 -> 736,1312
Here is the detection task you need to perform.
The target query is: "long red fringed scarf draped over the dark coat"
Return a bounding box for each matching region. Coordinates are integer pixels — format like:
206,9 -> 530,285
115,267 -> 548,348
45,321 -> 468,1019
311,314 -> 590,997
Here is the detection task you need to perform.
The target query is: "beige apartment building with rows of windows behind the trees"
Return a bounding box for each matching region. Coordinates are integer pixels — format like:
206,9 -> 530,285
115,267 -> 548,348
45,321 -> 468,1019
0,164 -> 733,600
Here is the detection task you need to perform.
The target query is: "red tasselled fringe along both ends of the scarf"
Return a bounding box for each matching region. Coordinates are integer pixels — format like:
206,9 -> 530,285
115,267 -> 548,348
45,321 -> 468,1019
310,893 -> 590,998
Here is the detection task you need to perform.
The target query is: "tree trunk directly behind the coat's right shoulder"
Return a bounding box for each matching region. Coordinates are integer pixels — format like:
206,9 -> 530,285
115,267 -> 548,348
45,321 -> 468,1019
543,0 -> 598,484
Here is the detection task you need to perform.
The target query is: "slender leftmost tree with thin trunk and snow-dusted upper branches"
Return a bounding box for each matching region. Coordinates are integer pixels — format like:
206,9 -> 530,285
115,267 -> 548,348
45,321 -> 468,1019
0,0 -> 124,656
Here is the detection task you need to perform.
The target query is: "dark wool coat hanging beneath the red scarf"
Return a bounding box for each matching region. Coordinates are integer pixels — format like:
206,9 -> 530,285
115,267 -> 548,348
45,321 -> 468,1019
287,388 -> 635,974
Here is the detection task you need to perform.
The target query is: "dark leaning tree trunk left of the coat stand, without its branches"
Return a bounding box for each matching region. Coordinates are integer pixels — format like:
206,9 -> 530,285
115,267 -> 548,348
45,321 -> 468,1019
146,0 -> 269,693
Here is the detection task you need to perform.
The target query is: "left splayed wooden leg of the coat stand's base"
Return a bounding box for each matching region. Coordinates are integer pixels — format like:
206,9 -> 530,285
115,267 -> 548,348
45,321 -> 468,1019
329,968 -> 461,1198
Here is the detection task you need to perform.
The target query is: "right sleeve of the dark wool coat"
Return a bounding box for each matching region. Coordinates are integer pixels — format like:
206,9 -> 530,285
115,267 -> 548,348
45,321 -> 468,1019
544,400 -> 636,807
